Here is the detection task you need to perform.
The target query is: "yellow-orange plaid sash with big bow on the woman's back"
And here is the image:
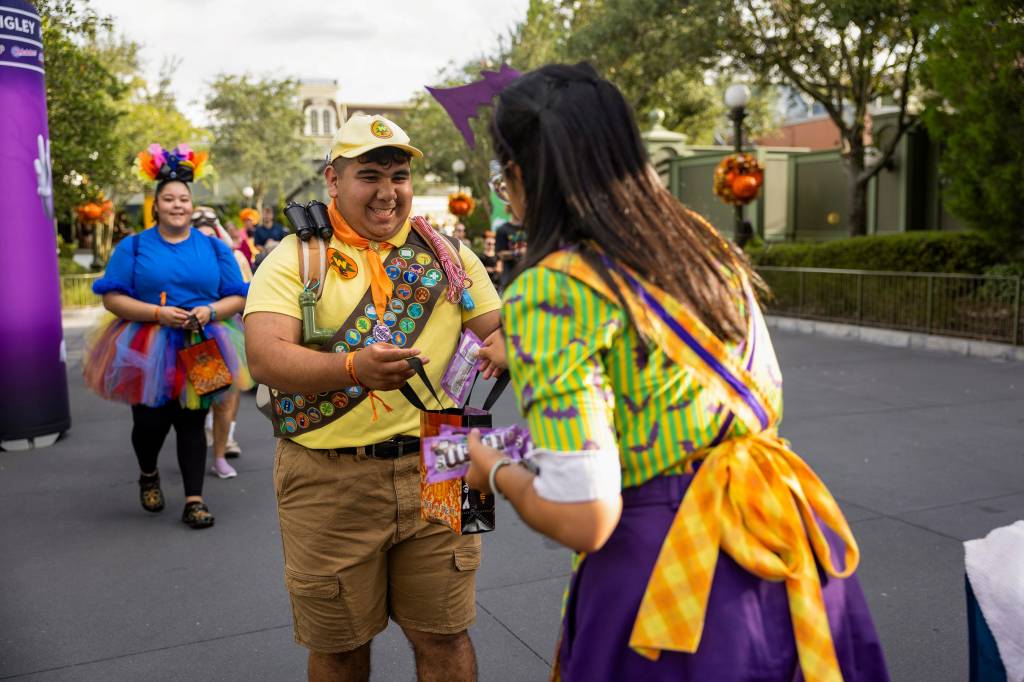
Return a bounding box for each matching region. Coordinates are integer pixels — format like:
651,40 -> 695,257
541,251 -> 860,682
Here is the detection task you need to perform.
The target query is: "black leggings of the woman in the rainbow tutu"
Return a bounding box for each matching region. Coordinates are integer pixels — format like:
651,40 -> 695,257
131,401 -> 207,497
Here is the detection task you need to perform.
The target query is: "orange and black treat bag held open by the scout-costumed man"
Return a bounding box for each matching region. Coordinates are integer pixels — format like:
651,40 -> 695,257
401,357 -> 509,536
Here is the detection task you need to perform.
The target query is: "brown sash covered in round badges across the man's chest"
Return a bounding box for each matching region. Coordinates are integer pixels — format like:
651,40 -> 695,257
270,230 -> 449,438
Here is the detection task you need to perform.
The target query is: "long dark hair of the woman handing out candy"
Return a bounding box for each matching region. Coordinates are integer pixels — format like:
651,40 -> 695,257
490,62 -> 760,341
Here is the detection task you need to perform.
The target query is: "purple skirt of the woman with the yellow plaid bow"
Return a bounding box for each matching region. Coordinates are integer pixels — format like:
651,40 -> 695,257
558,475 -> 889,682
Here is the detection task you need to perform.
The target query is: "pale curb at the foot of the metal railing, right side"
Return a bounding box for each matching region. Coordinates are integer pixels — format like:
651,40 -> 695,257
766,315 -> 1024,363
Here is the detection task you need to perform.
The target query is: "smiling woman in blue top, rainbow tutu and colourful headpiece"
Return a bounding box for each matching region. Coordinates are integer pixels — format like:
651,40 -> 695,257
83,144 -> 252,528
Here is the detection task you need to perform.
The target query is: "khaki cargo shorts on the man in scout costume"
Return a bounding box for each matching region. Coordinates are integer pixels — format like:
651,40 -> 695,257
273,438 -> 480,653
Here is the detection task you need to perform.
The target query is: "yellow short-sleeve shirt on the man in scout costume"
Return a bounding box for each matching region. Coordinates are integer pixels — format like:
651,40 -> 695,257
245,222 -> 501,449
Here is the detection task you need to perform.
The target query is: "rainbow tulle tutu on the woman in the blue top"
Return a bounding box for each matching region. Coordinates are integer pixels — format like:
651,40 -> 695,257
83,315 -> 253,410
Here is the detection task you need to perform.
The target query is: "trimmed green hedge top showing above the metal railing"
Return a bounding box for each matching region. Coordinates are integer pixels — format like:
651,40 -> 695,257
746,231 -> 1009,273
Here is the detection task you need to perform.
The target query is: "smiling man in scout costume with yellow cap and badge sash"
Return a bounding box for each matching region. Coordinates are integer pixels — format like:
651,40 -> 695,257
246,116 -> 501,680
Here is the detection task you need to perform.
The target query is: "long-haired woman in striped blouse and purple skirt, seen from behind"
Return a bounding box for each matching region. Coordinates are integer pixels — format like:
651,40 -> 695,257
468,65 -> 888,682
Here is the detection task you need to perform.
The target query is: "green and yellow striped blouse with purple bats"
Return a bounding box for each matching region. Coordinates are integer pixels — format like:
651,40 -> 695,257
503,267 -> 781,487
